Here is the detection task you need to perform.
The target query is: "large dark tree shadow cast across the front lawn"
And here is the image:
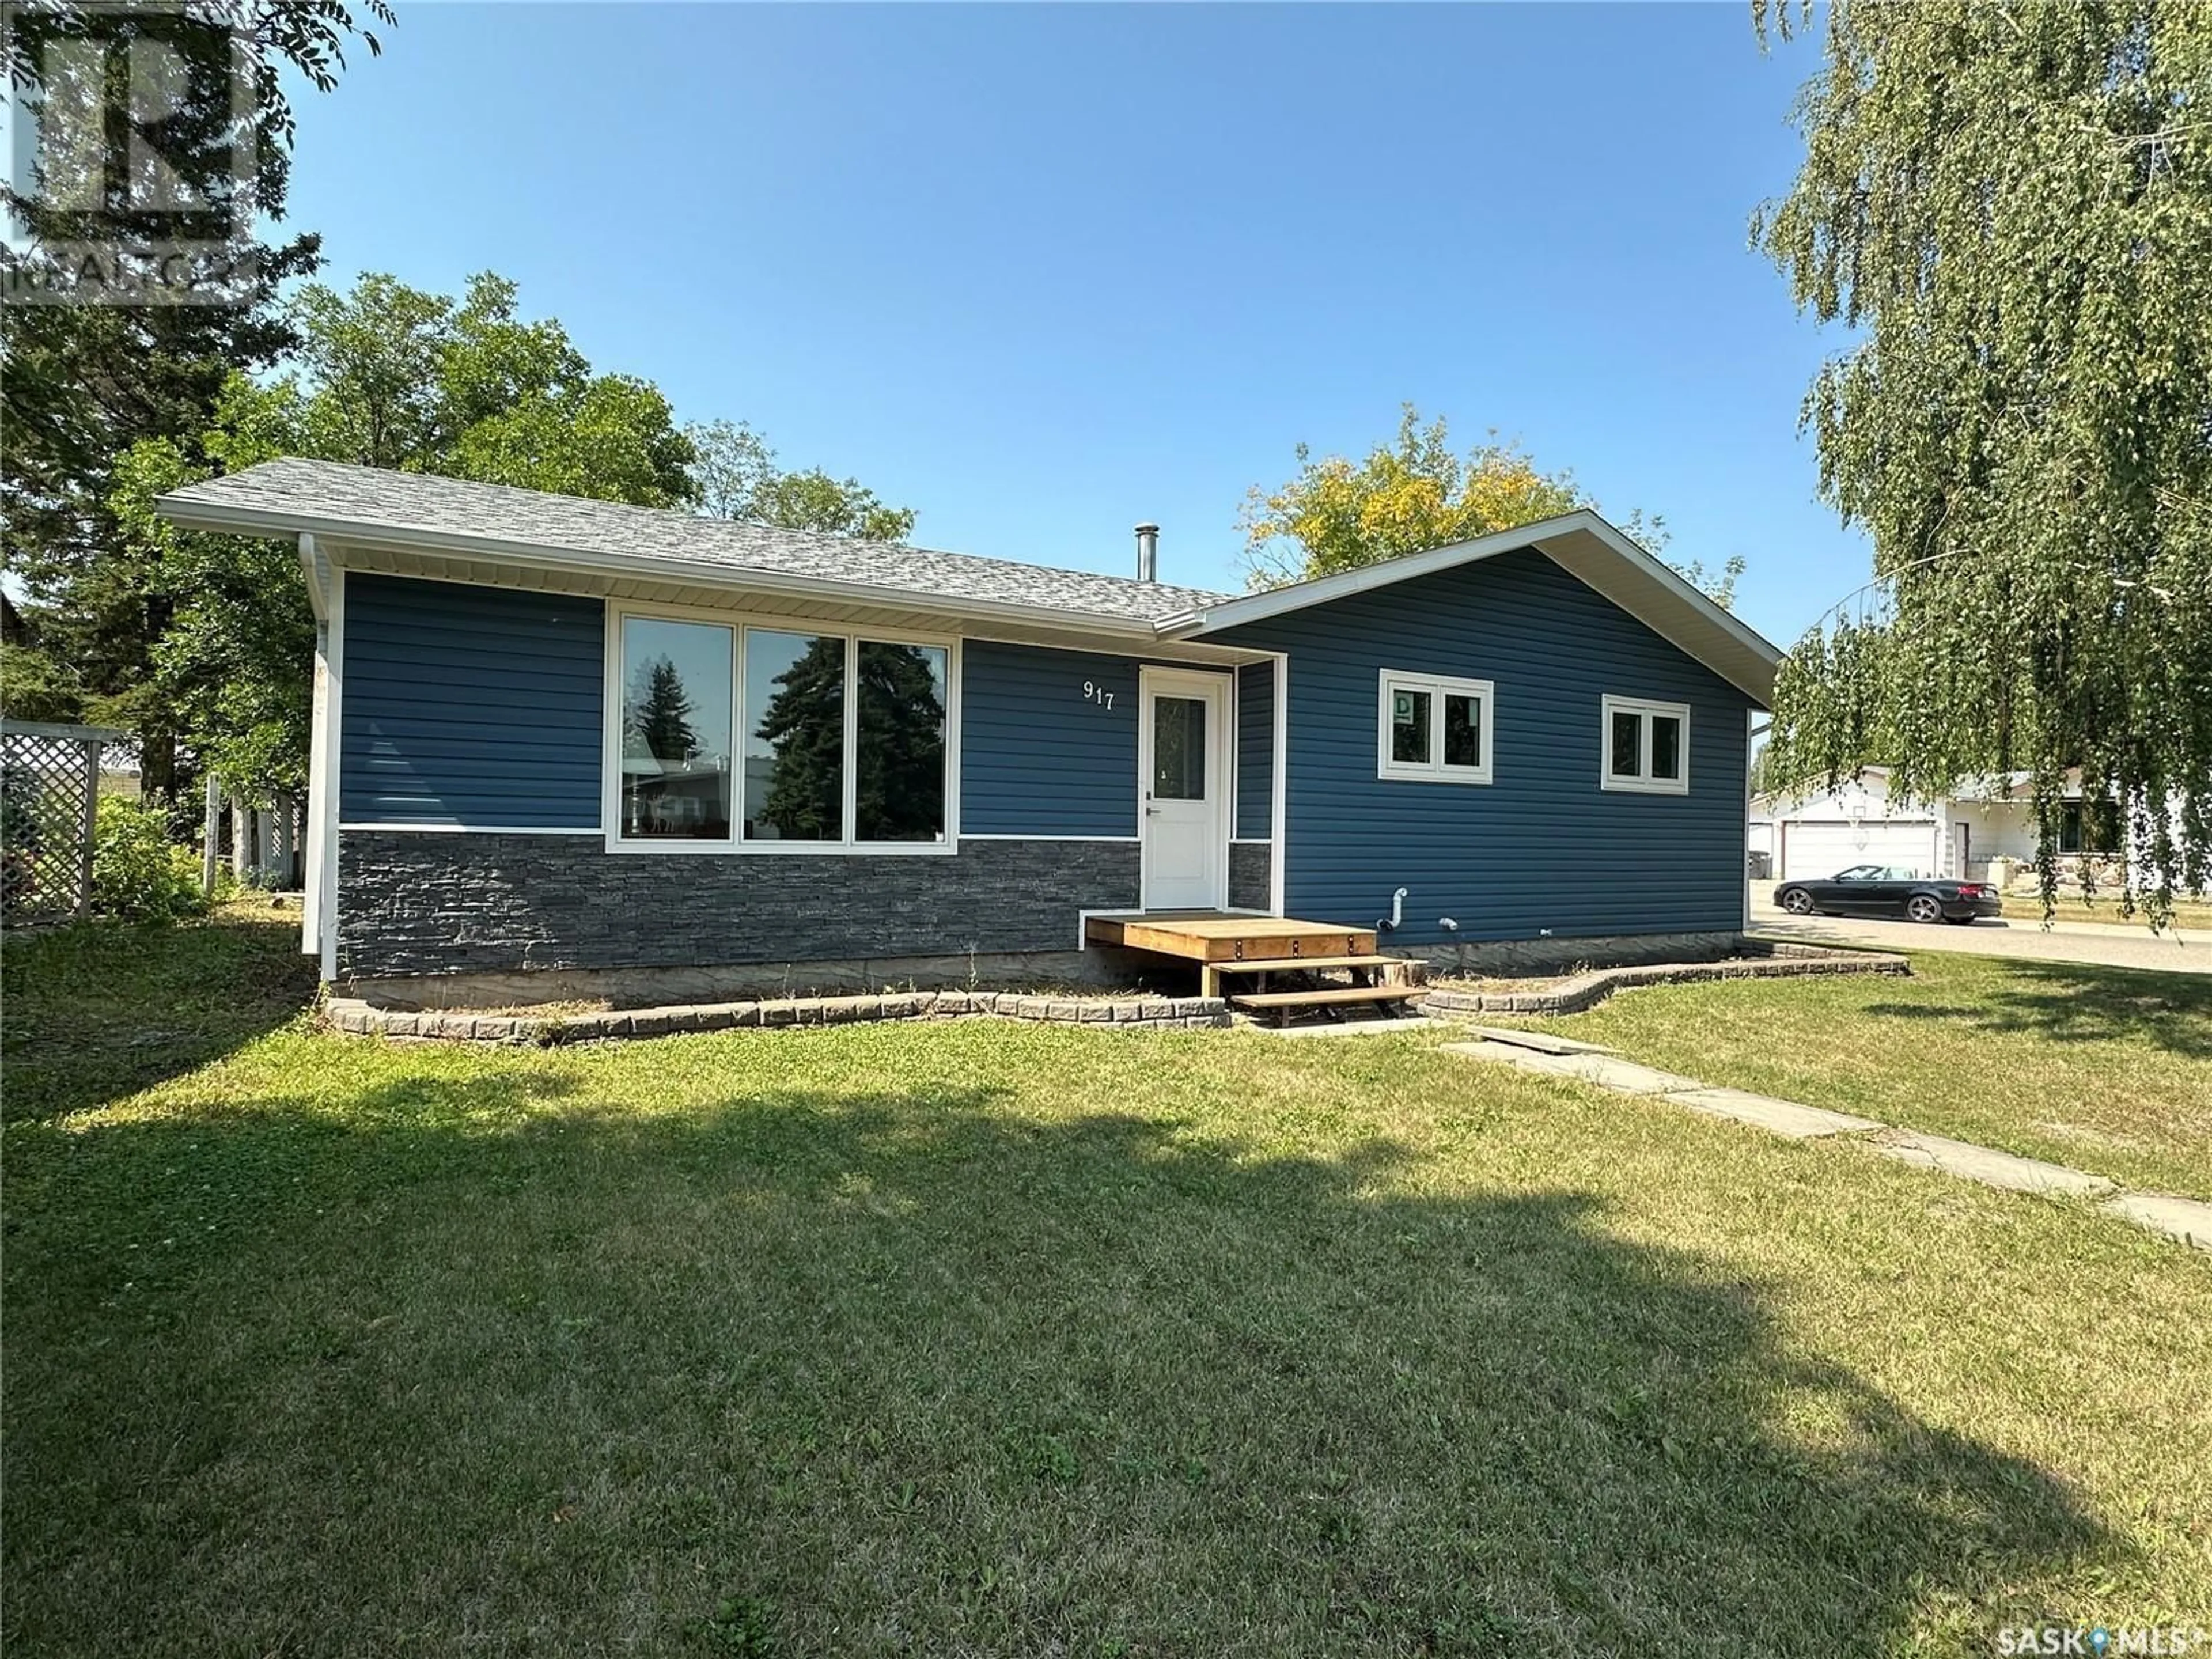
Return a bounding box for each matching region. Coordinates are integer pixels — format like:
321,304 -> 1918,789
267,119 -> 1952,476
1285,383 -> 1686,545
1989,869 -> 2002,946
5,1070 -> 2101,1654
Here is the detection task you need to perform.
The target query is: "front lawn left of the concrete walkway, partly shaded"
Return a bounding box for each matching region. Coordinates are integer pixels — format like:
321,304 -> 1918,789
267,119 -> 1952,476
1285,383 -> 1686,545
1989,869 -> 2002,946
13,918 -> 2212,1659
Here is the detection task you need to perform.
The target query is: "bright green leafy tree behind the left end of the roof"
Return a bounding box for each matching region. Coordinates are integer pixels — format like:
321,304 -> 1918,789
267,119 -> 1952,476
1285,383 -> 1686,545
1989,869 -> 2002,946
113,274 -> 695,794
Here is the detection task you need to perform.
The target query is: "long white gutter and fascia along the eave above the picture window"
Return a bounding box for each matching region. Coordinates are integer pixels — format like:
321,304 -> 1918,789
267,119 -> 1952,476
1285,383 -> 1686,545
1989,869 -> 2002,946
155,495 -> 1159,639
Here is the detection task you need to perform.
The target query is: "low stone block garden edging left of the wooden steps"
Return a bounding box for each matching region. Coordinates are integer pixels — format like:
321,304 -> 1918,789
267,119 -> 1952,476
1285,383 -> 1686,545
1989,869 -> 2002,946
325,991 -> 1230,1046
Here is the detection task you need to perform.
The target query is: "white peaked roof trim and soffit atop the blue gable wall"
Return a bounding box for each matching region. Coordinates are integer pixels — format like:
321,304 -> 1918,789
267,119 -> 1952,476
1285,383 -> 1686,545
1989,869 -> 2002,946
1159,509 -> 1783,706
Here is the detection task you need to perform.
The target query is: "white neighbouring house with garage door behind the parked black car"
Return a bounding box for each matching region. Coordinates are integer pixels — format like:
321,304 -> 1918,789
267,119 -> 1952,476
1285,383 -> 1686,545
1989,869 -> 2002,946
1748,766 -> 2115,880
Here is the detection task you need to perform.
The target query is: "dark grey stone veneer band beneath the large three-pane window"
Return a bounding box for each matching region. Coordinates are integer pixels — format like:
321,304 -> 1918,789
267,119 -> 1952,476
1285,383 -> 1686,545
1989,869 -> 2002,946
339,830 -> 1150,980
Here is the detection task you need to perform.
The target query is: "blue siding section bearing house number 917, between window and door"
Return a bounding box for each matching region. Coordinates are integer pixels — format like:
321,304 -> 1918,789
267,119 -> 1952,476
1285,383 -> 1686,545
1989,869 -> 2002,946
960,639 -> 1139,836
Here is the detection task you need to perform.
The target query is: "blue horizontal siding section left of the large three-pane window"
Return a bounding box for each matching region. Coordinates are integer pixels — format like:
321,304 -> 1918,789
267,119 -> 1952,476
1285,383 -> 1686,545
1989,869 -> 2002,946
339,575 -> 606,830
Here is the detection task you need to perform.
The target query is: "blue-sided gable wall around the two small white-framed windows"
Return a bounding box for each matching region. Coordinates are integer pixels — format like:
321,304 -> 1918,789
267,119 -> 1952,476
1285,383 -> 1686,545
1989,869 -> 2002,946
1217,551 -> 1752,945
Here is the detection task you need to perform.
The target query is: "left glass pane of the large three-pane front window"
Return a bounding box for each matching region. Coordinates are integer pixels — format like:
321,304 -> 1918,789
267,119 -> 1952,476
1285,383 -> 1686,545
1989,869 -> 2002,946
622,617 -> 730,840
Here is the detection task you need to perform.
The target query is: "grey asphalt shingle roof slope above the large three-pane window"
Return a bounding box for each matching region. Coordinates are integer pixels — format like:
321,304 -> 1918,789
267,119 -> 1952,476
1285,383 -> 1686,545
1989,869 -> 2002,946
164,460 -> 1228,622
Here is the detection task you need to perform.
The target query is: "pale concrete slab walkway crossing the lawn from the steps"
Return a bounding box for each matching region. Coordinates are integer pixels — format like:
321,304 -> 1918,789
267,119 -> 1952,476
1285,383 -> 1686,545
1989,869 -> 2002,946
1445,1027 -> 2212,1250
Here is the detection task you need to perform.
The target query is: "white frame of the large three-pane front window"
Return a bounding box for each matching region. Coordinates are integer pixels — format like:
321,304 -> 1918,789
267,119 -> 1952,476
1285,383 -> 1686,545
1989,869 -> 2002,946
600,601 -> 960,858
